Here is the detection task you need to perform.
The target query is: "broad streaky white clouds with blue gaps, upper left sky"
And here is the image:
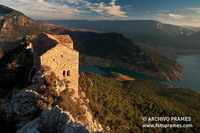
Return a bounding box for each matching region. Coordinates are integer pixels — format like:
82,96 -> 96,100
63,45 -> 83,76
0,0 -> 127,19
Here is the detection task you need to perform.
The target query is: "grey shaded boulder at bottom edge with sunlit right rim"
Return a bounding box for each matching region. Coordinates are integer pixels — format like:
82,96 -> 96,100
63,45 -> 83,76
17,106 -> 89,133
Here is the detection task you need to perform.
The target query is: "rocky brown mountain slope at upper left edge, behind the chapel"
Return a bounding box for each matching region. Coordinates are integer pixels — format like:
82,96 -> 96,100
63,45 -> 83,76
0,5 -> 57,51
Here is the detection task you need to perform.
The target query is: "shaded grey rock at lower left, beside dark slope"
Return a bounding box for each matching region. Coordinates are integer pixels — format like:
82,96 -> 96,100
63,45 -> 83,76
9,84 -> 43,128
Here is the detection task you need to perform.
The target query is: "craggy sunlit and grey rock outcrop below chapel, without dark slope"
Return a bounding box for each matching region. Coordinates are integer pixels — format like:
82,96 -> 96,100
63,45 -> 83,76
1,70 -> 103,133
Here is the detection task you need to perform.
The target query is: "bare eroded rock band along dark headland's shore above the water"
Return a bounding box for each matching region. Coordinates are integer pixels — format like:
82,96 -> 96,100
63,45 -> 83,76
79,55 -> 183,81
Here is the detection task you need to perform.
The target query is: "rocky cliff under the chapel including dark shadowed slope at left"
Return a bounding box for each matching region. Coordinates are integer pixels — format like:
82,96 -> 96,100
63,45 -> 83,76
0,33 -> 103,133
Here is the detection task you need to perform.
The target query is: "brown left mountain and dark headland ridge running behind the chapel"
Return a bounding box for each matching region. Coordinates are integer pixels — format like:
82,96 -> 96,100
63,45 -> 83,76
0,6 -> 184,81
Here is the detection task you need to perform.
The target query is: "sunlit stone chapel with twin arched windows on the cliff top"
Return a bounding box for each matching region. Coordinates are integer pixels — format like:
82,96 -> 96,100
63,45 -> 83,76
33,33 -> 79,97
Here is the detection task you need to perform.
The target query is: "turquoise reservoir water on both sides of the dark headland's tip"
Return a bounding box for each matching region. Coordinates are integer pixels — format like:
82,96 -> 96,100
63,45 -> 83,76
79,55 -> 200,91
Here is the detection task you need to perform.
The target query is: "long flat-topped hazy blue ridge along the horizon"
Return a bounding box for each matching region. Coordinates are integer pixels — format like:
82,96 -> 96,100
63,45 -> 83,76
43,20 -> 194,36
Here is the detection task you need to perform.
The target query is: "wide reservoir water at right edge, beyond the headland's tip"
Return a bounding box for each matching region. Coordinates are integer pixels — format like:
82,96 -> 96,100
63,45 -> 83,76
165,55 -> 200,91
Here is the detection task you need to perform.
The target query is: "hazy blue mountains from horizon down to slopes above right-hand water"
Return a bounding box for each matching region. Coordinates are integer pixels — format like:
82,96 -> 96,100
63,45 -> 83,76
42,20 -> 200,53
